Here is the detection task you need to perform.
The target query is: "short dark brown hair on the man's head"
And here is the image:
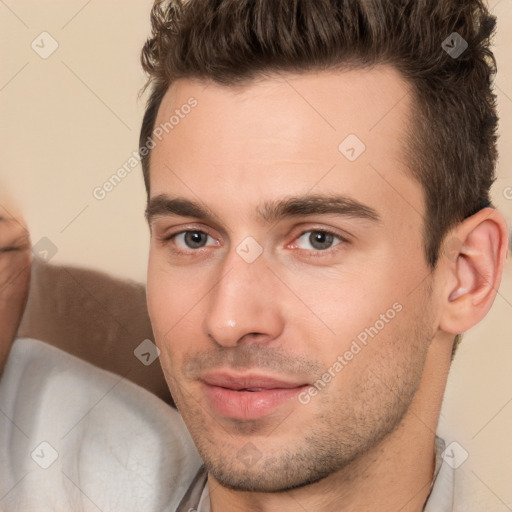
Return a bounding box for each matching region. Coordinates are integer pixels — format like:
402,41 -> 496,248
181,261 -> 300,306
140,0 -> 498,269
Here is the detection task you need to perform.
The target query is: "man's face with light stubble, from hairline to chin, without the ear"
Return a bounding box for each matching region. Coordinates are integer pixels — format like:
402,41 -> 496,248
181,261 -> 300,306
147,67 -> 434,491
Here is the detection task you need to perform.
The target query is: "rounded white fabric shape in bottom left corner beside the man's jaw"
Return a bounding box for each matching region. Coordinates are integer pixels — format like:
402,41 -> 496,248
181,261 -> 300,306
0,339 -> 201,511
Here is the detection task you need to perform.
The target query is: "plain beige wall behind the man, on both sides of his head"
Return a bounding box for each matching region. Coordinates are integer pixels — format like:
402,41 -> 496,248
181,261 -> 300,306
0,0 -> 512,511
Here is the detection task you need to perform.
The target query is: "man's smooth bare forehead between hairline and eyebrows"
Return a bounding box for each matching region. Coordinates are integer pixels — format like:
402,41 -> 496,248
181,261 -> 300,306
150,66 -> 423,232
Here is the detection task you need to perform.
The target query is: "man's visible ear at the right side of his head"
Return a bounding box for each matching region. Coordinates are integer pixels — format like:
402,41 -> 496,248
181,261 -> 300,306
439,208 -> 508,334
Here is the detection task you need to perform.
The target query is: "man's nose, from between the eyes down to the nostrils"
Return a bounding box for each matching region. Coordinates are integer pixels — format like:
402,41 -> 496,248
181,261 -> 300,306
203,243 -> 284,347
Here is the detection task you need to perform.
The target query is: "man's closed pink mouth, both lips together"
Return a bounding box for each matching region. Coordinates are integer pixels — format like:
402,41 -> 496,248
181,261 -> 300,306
201,373 -> 309,420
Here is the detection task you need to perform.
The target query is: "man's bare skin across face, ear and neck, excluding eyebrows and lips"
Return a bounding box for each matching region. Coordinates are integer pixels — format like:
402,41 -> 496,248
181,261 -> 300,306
147,66 -> 507,512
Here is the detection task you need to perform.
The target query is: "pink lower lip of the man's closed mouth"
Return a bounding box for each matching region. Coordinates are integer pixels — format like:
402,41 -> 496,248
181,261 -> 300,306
203,384 -> 307,420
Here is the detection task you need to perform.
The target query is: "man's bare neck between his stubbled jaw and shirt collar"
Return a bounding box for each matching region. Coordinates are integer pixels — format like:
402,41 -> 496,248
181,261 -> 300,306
208,336 -> 449,512
